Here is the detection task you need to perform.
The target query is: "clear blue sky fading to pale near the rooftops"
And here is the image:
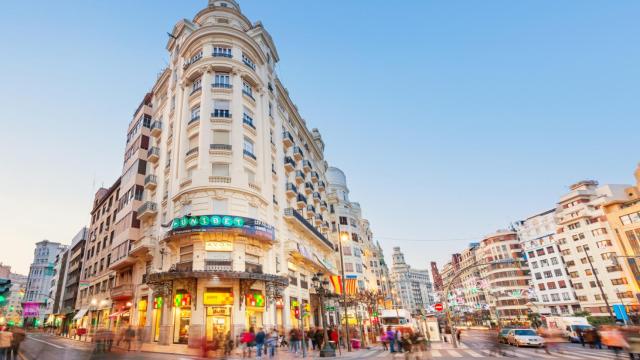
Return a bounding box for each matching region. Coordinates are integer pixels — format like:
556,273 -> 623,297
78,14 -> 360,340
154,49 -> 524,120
0,0 -> 640,273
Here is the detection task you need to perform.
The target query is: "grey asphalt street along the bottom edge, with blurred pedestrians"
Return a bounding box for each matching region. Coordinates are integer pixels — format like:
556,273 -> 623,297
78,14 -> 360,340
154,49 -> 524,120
21,331 -> 628,360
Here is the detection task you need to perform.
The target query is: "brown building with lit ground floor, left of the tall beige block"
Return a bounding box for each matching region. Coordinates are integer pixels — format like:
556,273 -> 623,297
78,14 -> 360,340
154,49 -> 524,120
73,178 -> 121,333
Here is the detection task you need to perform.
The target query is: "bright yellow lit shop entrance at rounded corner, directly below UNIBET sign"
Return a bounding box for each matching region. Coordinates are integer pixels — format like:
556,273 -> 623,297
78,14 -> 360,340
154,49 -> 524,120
202,288 -> 233,341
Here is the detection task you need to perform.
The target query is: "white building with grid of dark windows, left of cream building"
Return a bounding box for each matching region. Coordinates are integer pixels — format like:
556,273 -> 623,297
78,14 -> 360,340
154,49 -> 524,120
516,209 -> 580,315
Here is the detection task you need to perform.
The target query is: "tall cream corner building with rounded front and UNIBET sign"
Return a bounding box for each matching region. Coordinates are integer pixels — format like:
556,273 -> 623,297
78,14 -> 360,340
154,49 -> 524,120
129,0 -> 337,347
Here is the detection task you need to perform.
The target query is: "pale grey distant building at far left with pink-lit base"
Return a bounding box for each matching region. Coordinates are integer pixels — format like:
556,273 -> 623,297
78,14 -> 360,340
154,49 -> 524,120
22,240 -> 65,326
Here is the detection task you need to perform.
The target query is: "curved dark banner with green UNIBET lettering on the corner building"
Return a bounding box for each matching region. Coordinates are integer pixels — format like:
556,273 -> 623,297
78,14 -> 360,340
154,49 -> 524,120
171,215 -> 275,241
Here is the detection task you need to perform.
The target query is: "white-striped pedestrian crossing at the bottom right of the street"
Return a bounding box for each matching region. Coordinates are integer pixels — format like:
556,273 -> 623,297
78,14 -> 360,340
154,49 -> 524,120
358,348 -> 627,360
